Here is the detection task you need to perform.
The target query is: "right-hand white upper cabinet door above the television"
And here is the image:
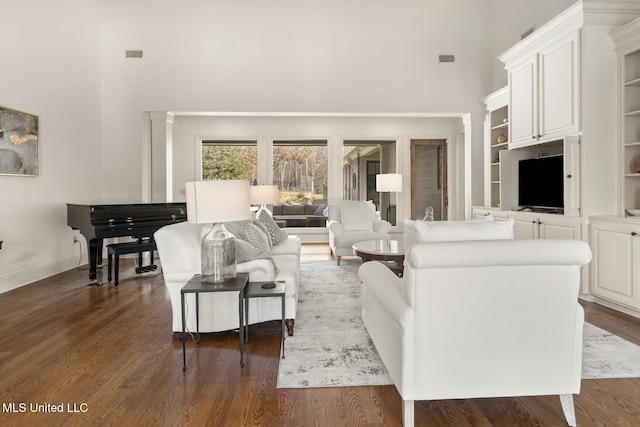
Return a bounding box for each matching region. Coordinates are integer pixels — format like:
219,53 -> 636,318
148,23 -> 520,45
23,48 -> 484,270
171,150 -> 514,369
537,33 -> 580,141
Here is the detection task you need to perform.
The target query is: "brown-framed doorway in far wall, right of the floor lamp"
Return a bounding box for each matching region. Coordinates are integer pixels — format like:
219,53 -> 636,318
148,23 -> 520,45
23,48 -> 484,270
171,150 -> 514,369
411,139 -> 449,221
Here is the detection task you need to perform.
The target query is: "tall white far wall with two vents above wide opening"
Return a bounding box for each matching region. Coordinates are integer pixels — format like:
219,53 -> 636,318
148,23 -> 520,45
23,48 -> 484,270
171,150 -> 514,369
102,0 -> 492,202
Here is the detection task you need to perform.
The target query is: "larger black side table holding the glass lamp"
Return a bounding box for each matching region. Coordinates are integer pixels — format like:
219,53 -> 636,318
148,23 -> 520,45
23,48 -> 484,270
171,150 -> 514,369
180,273 -> 250,371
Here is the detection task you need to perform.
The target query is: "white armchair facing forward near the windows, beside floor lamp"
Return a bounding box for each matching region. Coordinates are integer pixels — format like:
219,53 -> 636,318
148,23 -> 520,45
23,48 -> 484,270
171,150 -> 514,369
327,200 -> 391,265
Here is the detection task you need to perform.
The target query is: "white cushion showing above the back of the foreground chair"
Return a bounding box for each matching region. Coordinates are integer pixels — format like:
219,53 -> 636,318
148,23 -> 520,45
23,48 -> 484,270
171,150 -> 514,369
414,219 -> 513,242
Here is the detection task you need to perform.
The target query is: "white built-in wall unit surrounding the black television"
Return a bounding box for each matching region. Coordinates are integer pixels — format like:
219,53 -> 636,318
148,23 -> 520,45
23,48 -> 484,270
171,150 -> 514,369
472,0 -> 640,317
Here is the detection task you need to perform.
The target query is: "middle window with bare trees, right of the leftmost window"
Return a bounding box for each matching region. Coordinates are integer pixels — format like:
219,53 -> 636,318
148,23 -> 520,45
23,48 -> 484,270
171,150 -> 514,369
273,140 -> 328,205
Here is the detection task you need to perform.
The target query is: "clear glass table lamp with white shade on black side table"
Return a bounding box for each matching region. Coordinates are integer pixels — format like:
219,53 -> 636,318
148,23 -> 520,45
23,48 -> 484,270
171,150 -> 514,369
186,180 -> 251,283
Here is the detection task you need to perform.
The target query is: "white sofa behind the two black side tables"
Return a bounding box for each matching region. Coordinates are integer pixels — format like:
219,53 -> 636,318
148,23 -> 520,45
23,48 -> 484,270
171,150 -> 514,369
154,222 -> 301,335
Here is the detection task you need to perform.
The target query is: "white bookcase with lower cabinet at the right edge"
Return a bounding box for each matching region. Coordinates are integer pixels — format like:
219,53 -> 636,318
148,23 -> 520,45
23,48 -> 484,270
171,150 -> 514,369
589,18 -> 640,317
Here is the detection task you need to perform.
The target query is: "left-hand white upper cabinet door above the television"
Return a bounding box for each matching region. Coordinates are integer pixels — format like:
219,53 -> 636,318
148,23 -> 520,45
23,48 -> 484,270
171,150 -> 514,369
509,55 -> 538,148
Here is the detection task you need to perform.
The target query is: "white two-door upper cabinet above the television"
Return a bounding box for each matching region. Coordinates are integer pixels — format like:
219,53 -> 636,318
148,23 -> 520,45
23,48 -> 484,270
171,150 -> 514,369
500,24 -> 580,148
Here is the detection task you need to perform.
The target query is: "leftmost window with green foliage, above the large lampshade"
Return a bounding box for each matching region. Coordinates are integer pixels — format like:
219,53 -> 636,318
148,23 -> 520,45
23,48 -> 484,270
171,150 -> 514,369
202,141 -> 258,182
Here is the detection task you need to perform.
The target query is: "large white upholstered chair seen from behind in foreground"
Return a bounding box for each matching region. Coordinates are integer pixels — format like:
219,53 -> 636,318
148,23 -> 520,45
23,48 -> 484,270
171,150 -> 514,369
359,240 -> 591,426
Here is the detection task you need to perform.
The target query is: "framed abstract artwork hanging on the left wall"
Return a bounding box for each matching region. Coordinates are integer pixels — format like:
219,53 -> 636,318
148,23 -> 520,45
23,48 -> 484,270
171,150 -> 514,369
0,107 -> 38,176
